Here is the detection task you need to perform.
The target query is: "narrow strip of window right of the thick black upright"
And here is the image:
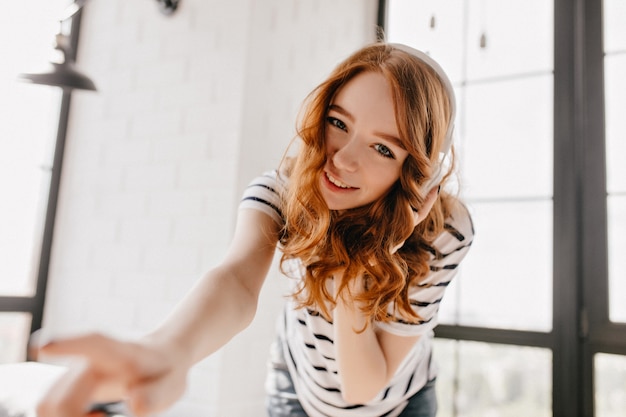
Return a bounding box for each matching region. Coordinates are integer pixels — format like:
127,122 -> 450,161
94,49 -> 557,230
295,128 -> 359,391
588,0 -> 626,417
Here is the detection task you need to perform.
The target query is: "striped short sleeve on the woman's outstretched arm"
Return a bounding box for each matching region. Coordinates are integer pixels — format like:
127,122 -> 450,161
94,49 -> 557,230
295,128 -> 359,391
239,171 -> 285,227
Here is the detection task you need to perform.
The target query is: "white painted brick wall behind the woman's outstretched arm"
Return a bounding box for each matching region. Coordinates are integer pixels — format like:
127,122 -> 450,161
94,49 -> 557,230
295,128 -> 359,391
44,0 -> 377,417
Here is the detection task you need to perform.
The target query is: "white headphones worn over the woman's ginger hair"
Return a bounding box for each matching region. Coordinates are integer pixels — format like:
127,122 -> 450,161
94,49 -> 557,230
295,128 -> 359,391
389,43 -> 456,193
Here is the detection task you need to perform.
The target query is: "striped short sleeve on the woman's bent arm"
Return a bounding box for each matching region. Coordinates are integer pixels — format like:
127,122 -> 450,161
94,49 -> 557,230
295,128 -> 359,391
377,204 -> 474,336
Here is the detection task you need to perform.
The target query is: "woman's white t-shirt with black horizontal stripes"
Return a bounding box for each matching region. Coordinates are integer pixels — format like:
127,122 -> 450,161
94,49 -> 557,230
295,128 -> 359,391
240,171 -> 474,417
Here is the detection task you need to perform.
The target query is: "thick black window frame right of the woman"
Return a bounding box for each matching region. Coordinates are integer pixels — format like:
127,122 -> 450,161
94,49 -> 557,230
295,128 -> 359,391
377,0 -> 626,417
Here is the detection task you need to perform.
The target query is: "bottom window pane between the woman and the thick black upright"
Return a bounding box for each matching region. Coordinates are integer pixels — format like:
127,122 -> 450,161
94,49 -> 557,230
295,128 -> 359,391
434,339 -> 552,417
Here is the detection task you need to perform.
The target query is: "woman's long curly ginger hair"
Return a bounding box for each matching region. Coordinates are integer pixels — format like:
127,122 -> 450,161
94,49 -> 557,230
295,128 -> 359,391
281,43 -> 457,322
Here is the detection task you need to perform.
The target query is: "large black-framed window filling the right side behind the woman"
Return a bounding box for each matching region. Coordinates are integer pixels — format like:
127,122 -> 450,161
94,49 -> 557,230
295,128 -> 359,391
379,0 -> 626,417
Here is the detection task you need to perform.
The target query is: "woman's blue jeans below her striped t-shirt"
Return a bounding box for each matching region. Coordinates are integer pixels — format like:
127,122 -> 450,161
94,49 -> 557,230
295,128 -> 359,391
265,341 -> 437,417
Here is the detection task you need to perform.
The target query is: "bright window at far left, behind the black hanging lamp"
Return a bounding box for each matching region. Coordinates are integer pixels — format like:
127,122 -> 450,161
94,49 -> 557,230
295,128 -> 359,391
0,0 -> 66,363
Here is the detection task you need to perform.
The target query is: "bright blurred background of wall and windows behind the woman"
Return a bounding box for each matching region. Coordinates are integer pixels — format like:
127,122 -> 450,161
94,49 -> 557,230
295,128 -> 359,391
0,0 -> 626,417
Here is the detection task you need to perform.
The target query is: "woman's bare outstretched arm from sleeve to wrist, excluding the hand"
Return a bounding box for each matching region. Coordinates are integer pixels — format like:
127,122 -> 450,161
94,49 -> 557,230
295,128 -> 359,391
146,209 -> 278,363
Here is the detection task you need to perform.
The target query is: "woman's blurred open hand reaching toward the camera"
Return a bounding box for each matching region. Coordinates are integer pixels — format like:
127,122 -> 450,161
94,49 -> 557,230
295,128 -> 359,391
37,334 -> 188,417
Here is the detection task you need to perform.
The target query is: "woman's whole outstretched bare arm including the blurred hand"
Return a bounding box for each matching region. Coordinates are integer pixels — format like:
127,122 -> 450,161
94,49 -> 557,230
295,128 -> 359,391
37,209 -> 278,417
